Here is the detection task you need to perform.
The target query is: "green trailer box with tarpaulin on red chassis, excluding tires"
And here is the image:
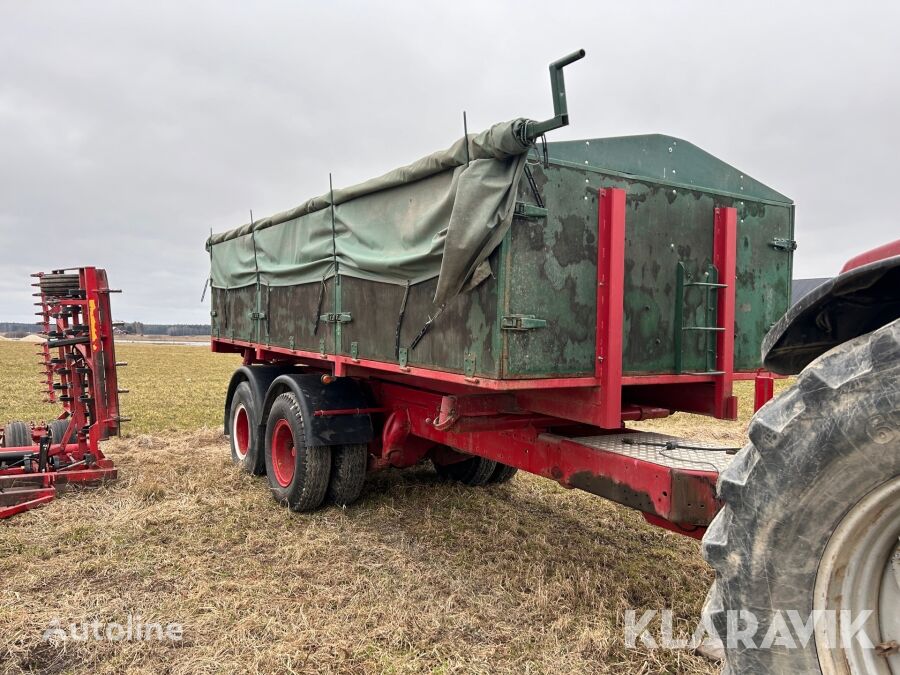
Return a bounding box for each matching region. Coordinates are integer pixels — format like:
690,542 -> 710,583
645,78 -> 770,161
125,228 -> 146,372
207,52 -> 795,536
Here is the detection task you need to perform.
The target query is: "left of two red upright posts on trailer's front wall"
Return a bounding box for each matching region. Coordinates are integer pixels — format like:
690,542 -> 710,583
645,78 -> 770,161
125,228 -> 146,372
594,188 -> 625,429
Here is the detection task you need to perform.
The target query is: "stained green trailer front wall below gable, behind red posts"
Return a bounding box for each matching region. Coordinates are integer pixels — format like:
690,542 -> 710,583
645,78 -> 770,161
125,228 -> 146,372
500,161 -> 793,378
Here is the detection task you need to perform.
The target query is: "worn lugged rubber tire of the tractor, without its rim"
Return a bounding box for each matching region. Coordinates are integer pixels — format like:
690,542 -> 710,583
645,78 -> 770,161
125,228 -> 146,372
703,320 -> 900,675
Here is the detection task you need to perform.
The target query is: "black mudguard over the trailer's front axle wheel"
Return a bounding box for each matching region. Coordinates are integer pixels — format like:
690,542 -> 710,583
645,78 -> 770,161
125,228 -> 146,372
260,373 -> 374,447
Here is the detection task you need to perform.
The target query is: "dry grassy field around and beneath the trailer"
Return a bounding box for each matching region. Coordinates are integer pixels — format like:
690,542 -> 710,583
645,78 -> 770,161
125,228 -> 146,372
0,342 -> 788,673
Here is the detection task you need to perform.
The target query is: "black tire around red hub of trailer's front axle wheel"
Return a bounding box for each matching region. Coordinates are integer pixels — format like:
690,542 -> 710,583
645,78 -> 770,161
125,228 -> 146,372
264,392 -> 331,511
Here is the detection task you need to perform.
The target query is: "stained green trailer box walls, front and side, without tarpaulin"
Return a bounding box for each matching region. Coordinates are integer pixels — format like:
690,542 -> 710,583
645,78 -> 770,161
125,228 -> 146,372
212,127 -> 794,380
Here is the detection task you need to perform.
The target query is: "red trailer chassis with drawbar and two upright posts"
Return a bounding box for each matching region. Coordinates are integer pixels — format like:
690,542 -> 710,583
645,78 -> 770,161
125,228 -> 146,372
212,189 -> 774,538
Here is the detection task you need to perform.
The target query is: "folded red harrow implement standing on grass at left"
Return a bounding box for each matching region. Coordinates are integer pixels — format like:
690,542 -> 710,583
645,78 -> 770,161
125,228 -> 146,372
0,267 -> 127,518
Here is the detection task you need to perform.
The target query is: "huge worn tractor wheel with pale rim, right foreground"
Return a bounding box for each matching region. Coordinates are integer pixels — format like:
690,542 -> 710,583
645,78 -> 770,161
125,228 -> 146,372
703,320 -> 900,674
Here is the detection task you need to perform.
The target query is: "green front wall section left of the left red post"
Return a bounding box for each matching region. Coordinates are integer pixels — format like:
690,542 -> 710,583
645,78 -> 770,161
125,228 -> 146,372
501,165 -> 597,379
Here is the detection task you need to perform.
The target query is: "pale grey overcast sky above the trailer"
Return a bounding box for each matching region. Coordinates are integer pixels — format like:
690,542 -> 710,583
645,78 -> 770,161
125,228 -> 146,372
0,0 -> 900,323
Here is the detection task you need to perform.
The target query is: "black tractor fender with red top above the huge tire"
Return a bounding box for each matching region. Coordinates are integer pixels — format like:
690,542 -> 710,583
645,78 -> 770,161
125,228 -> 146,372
762,251 -> 900,375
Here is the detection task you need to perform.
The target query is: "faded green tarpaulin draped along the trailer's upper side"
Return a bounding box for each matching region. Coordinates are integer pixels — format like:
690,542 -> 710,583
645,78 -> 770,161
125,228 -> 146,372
207,119 -> 530,305
